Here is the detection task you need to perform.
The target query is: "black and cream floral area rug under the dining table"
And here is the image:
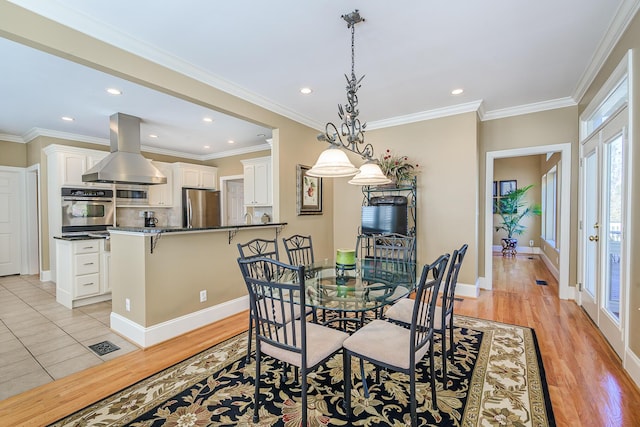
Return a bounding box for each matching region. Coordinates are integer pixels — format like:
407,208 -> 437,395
53,316 -> 555,427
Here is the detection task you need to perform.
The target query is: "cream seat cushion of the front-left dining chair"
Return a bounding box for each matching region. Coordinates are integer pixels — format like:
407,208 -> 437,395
260,320 -> 349,368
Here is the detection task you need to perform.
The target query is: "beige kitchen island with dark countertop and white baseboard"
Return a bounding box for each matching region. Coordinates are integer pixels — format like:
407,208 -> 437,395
109,223 -> 286,347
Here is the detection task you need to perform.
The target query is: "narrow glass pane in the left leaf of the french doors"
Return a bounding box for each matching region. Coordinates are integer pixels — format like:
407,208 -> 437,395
583,150 -> 598,299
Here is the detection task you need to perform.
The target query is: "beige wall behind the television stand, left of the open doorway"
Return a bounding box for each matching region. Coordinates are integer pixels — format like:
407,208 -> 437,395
333,113 -> 478,284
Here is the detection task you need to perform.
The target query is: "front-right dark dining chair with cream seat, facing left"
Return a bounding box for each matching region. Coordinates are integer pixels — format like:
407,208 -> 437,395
342,254 -> 449,427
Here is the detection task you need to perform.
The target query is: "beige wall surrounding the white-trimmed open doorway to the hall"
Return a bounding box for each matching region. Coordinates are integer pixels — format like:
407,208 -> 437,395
478,107 -> 578,285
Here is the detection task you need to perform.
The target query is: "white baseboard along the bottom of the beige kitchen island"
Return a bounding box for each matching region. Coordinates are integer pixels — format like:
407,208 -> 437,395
111,296 -> 249,348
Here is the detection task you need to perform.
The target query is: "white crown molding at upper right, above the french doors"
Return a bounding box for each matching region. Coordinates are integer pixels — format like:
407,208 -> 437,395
572,0 -> 640,101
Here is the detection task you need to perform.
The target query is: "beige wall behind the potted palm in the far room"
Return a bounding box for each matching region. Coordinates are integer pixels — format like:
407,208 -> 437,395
493,155 -> 543,247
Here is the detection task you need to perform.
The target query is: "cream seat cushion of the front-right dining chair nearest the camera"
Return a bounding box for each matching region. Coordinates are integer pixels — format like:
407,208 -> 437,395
342,319 -> 429,369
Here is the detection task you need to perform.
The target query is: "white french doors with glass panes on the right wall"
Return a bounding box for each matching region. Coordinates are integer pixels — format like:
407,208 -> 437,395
580,108 -> 628,356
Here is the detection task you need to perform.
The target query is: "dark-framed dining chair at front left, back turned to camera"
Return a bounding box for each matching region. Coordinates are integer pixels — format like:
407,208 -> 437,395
238,258 -> 349,426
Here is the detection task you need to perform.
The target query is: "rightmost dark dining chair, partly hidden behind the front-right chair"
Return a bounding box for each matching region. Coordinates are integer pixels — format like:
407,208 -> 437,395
385,243 -> 469,388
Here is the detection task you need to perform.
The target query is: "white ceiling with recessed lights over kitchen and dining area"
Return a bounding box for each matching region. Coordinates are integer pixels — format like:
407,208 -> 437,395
0,0 -> 640,159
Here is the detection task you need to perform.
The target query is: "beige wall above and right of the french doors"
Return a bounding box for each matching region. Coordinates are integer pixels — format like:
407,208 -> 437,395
579,10 -> 640,357
